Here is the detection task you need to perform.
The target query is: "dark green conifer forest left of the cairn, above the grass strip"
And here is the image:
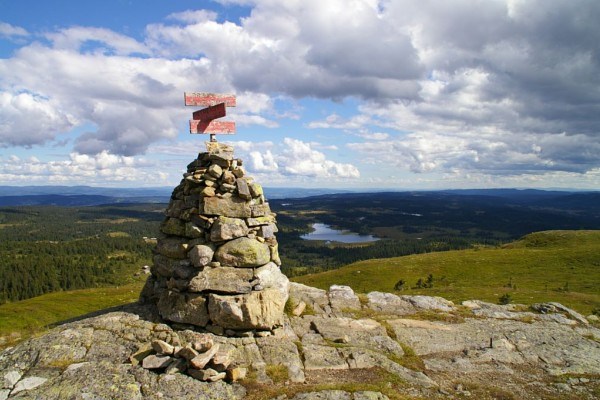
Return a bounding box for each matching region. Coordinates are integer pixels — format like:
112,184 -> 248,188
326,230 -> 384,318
0,205 -> 163,303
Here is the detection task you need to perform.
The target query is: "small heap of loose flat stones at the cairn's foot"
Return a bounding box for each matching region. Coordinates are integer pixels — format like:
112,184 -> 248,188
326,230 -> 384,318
130,336 -> 247,382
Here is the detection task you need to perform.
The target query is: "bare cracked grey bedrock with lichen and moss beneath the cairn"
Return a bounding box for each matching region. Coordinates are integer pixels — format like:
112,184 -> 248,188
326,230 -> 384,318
0,283 -> 600,400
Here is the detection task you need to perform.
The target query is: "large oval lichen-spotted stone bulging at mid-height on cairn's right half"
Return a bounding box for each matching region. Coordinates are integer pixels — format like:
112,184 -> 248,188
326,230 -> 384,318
215,237 -> 271,268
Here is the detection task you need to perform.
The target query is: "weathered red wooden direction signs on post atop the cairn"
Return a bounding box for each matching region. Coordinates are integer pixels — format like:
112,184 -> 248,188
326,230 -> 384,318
184,92 -> 236,142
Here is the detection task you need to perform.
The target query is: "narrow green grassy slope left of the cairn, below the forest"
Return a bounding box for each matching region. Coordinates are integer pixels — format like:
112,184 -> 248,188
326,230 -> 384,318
0,282 -> 143,348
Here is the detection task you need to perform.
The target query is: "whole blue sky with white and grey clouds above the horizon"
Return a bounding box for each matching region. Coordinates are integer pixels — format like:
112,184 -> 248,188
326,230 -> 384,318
0,0 -> 600,190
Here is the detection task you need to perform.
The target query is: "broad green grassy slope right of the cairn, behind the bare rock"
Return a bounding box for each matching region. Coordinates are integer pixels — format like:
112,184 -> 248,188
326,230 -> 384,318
293,231 -> 600,315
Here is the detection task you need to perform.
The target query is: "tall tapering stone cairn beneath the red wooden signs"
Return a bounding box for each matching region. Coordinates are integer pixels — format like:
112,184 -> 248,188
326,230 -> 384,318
142,142 -> 289,336
